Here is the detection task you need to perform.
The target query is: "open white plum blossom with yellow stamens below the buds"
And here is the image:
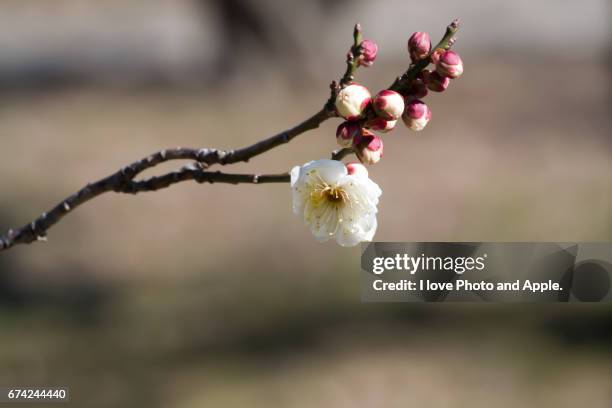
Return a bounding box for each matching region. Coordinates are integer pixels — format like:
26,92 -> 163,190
291,160 -> 381,247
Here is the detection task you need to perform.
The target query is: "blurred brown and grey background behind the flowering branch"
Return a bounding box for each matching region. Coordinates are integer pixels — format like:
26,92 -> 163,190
0,0 -> 612,408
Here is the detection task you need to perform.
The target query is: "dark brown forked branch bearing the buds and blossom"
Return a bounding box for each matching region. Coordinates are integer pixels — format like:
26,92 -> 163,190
0,21 -> 458,255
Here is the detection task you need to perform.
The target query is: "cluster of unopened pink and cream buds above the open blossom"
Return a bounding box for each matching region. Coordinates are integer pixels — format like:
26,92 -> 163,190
335,26 -> 463,164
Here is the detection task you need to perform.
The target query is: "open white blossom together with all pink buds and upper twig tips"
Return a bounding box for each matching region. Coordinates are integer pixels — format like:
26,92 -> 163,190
291,20 -> 463,246
